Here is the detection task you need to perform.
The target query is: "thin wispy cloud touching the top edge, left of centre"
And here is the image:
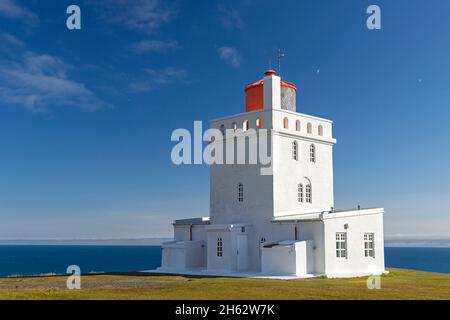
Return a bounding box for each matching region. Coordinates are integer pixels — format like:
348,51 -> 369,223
96,0 -> 177,33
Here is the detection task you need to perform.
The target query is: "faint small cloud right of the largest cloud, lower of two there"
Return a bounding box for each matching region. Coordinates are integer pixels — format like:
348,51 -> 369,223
130,67 -> 187,92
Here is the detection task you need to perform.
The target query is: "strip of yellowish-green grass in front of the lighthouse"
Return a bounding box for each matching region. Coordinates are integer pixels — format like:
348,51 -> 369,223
0,269 -> 450,300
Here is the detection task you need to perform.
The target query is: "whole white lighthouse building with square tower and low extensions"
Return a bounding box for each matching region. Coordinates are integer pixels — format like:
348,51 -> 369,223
158,70 -> 385,277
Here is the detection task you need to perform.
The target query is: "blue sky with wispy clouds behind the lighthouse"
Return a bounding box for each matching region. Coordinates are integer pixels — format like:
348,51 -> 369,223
0,0 -> 450,239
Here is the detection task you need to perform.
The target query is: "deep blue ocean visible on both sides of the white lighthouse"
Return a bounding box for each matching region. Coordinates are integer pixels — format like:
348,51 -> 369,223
0,245 -> 450,277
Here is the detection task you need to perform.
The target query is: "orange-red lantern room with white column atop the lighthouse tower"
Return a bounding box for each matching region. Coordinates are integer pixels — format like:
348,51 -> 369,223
245,70 -> 297,112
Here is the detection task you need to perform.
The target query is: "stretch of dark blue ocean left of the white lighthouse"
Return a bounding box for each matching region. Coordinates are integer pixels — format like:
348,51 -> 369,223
0,245 -> 161,277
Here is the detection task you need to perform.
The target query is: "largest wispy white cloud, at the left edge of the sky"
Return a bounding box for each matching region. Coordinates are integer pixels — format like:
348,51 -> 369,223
0,39 -> 109,113
